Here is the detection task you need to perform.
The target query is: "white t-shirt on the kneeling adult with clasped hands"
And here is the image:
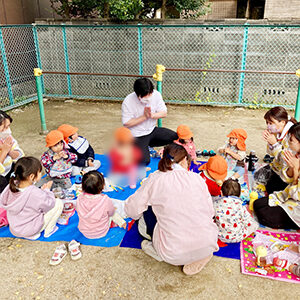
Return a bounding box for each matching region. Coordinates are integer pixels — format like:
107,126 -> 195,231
122,90 -> 167,137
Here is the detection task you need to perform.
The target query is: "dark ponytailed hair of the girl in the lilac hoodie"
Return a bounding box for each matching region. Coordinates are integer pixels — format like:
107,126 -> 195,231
9,156 -> 42,193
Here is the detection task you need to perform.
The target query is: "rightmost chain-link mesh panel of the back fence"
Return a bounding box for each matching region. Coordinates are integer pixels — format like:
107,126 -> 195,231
243,27 -> 300,106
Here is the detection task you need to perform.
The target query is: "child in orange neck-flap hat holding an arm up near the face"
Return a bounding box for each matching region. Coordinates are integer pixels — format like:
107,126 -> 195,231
218,128 -> 247,179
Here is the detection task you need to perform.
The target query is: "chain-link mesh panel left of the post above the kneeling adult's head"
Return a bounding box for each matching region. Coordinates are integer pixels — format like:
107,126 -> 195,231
65,27 -> 139,98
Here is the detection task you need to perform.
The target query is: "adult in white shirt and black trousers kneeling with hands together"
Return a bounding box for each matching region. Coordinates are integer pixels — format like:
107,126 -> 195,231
122,78 -> 178,165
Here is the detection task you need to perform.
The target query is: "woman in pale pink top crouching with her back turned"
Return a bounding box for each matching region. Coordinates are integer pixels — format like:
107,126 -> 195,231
125,143 -> 218,275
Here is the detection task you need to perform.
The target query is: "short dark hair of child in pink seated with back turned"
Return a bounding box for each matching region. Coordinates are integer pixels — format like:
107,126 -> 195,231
82,171 -> 105,195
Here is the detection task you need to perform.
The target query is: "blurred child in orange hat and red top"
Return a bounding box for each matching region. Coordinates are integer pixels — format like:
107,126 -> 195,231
109,127 -> 142,188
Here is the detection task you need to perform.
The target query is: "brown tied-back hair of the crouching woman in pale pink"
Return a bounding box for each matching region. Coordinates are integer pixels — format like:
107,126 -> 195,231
158,143 -> 191,172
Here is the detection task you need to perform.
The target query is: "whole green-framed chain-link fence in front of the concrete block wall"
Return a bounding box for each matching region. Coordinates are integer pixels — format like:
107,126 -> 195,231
0,24 -> 300,108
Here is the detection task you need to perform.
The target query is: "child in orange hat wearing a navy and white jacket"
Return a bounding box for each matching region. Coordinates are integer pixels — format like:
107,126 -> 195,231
58,124 -> 101,176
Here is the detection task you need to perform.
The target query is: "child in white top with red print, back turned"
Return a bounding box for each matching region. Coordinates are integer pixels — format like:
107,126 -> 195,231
213,179 -> 259,243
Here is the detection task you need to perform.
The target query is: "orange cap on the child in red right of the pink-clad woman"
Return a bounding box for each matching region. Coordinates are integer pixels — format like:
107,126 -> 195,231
199,155 -> 227,180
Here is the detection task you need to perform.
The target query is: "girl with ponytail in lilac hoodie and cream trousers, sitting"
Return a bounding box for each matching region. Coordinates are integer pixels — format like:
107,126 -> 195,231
0,156 -> 63,240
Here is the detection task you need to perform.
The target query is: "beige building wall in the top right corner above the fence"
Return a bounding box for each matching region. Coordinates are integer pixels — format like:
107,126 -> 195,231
264,0 -> 300,19
